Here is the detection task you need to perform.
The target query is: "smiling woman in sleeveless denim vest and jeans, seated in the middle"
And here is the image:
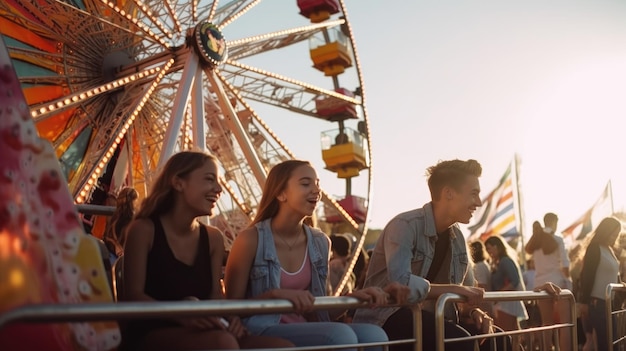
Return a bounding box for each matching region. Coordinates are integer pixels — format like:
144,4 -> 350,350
224,160 -> 408,346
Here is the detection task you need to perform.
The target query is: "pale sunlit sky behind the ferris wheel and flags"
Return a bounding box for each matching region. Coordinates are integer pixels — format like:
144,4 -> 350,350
226,0 -> 626,235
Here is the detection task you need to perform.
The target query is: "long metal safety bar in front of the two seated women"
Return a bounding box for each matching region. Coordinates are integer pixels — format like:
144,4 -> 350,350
0,296 -> 422,351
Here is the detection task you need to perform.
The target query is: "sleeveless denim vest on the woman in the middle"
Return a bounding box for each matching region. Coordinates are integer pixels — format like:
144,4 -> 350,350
243,219 -> 330,335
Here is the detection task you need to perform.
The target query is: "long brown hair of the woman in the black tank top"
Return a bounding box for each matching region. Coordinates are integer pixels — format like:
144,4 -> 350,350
136,151 -> 217,218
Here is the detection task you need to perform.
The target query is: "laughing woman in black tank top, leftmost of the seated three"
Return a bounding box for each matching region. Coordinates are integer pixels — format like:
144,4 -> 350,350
122,151 -> 293,351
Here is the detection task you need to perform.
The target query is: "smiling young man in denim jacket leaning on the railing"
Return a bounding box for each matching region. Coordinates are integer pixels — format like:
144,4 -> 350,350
354,160 -> 490,351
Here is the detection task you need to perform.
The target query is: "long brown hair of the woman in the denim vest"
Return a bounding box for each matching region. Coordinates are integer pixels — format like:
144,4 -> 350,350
250,160 -> 311,226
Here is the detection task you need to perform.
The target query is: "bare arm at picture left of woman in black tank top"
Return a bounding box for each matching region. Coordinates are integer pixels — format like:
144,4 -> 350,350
123,219 -> 155,301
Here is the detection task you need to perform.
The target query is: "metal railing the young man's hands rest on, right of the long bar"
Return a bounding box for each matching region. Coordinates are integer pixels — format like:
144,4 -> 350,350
435,289 -> 578,351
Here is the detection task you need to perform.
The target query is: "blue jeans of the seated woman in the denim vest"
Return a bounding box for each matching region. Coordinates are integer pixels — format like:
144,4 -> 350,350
260,322 -> 389,351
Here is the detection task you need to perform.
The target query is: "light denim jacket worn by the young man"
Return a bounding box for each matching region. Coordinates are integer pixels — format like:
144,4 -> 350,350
354,202 -> 474,326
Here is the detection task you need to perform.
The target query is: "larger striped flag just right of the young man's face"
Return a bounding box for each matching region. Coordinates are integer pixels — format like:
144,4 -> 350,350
468,162 -> 520,242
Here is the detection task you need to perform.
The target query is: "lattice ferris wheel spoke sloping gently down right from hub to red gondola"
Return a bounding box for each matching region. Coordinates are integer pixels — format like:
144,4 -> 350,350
221,61 -> 361,118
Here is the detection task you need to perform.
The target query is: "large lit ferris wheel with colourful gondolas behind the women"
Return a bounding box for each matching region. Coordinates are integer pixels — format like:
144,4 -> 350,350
0,0 -> 371,245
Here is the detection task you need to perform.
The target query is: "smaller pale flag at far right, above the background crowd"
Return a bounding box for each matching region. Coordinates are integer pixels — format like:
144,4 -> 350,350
561,181 -> 613,243
